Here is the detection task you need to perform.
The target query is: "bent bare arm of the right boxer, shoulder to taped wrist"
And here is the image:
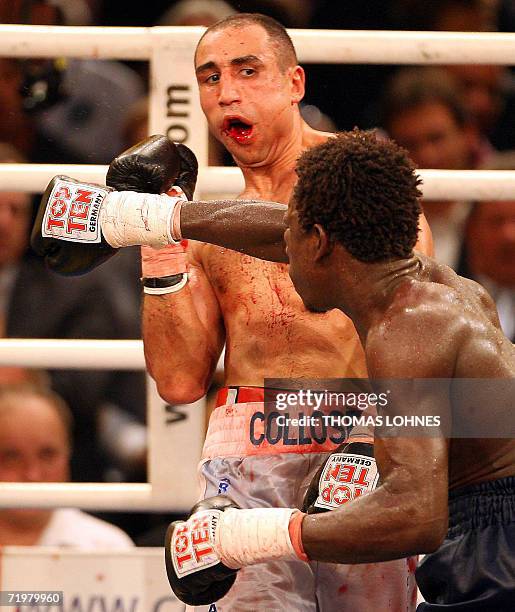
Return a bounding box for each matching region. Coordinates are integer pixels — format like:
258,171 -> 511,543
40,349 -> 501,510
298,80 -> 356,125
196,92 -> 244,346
302,304 -> 455,563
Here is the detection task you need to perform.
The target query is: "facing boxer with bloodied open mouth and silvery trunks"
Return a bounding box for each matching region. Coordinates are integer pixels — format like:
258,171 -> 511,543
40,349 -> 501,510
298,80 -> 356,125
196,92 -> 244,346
136,14 -> 429,612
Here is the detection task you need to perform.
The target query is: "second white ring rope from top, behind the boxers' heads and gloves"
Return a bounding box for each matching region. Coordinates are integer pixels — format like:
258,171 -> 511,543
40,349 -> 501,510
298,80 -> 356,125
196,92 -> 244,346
0,163 -> 515,201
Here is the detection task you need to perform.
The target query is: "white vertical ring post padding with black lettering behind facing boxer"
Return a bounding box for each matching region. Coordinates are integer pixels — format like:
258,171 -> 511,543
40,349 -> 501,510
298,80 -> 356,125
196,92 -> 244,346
147,27 -> 208,511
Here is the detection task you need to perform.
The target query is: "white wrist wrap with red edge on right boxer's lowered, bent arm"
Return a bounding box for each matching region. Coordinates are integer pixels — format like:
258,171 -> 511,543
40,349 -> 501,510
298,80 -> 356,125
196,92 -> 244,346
215,508 -> 298,569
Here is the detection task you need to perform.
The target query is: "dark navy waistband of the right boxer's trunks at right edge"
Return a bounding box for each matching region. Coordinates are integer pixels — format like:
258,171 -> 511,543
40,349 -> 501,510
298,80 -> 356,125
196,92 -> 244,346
447,476 -> 515,538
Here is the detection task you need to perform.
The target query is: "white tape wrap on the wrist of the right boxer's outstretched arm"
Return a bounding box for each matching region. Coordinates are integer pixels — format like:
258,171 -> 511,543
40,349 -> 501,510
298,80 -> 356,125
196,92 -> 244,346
100,191 -> 186,248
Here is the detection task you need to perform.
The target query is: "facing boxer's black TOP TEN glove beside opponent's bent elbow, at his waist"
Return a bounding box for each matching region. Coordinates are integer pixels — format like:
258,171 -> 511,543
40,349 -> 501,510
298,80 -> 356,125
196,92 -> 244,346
302,433 -> 379,514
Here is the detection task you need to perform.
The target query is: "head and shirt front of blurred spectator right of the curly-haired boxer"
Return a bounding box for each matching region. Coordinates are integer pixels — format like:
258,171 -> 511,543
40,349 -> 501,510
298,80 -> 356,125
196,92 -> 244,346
380,68 -> 484,268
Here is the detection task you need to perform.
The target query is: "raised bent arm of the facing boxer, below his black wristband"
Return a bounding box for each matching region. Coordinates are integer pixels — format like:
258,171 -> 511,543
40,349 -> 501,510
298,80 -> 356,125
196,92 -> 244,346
142,244 -> 225,404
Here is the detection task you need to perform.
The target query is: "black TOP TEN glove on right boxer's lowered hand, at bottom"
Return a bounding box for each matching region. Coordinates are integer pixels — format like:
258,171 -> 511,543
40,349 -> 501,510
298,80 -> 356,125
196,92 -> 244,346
165,495 -> 242,606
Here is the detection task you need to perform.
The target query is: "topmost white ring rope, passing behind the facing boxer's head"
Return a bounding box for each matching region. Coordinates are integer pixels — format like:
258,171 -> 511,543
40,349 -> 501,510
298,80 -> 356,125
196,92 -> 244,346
0,25 -> 515,65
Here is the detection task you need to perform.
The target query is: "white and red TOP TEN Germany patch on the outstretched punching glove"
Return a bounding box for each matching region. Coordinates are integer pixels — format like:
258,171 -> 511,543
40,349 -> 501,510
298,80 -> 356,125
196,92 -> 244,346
41,179 -> 110,243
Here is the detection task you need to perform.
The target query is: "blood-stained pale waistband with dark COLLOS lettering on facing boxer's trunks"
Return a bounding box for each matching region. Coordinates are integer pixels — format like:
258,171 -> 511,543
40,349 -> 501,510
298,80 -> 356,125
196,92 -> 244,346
202,396 -> 358,460
